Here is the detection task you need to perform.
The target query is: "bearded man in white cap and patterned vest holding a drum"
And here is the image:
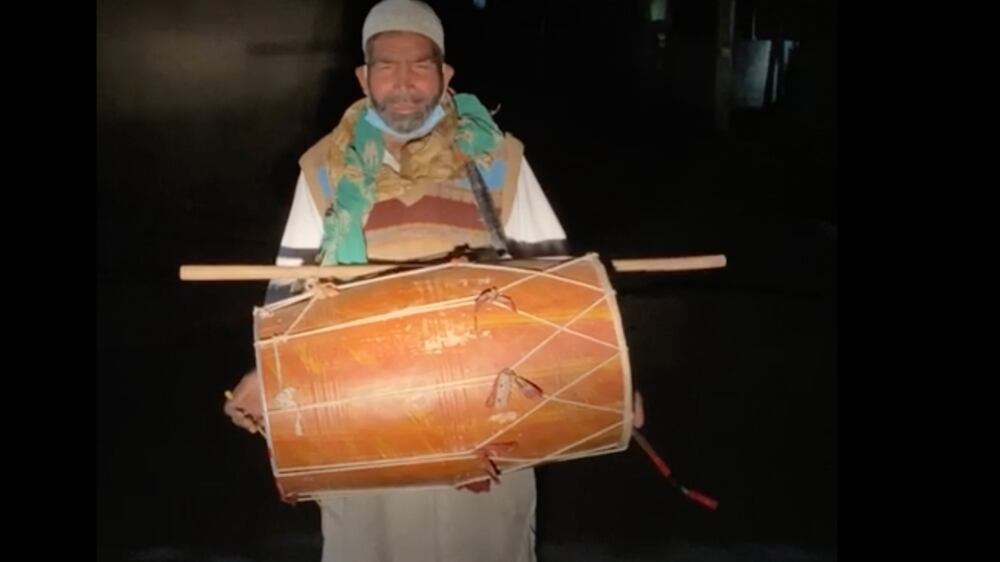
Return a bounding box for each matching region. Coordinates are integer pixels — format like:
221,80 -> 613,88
225,0 -> 641,562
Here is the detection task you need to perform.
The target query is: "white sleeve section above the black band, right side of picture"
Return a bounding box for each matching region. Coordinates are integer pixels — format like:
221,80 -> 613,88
504,157 -> 566,243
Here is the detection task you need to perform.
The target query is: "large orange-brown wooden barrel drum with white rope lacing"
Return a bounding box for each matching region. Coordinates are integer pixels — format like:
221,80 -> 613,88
254,254 -> 632,499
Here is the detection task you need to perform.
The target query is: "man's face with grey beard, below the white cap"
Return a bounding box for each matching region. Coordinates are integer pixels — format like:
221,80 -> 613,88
357,31 -> 454,133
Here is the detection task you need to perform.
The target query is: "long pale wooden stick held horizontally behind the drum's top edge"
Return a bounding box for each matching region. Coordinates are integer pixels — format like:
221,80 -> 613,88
180,254 -> 726,281
